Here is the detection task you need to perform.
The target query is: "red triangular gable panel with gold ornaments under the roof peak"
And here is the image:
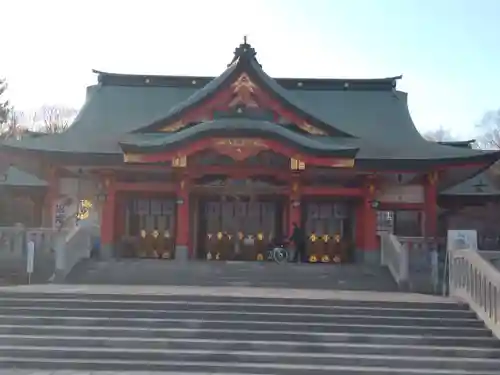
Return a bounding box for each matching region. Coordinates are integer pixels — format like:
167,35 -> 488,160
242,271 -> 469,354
160,72 -> 326,135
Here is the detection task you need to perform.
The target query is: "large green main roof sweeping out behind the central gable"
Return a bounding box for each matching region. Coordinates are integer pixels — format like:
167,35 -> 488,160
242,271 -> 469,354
0,39 -> 499,169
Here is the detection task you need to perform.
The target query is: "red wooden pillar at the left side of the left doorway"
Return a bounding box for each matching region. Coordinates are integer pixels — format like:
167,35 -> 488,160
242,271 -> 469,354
100,177 -> 116,258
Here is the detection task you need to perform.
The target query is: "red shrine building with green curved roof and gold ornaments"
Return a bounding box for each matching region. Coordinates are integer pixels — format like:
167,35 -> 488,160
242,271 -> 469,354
2,40 -> 500,263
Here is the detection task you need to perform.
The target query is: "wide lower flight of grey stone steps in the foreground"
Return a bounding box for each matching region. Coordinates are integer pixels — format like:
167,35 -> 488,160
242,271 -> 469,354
0,286 -> 500,375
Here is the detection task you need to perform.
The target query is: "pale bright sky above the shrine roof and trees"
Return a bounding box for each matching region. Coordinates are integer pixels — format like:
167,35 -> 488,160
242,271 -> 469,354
0,0 -> 500,139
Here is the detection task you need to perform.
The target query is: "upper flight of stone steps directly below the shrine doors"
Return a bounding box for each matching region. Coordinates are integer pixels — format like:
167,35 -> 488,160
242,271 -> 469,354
66,259 -> 398,292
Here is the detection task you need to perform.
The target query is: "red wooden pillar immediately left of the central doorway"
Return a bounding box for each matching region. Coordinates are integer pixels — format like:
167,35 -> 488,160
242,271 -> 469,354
175,177 -> 192,260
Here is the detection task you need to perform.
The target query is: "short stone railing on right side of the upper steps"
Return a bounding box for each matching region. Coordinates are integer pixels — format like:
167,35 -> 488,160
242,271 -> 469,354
380,233 -> 409,289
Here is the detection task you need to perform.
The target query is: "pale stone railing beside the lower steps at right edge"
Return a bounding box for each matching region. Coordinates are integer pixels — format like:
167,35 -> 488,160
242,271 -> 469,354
448,250 -> 500,338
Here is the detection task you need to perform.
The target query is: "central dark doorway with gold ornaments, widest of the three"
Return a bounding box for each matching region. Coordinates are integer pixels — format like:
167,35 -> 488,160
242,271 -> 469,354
197,196 -> 283,260
